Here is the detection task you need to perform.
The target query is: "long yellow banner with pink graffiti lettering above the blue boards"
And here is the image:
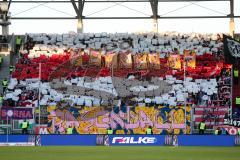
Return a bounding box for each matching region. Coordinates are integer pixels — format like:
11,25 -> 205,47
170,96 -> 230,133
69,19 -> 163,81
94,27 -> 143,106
47,106 -> 191,134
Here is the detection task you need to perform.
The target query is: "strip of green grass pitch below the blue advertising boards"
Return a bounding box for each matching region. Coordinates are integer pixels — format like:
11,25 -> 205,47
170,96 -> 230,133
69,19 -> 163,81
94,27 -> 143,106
0,146 -> 240,160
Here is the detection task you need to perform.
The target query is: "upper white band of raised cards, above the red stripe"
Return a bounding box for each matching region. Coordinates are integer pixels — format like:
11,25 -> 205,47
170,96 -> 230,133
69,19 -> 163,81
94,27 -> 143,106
25,32 -> 223,58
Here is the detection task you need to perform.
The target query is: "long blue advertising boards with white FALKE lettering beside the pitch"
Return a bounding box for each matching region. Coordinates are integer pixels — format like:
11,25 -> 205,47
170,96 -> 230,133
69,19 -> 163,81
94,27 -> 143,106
0,135 -> 237,146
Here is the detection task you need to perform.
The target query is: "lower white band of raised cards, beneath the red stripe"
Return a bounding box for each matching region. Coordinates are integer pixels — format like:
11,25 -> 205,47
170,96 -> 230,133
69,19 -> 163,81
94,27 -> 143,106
4,75 -> 218,107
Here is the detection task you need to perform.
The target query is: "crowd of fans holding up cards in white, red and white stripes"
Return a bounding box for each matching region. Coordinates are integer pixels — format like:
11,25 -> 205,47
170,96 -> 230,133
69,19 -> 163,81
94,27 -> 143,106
0,33 -> 231,132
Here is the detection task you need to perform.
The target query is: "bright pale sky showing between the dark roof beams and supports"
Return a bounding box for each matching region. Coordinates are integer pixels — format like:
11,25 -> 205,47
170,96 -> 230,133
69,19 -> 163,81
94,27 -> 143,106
5,0 -> 240,34
